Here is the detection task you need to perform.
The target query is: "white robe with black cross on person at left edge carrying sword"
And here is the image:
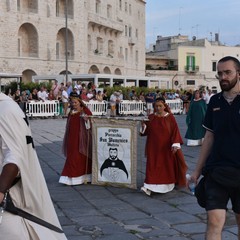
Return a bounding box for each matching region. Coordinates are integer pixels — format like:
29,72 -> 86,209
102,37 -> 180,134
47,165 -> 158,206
0,93 -> 67,240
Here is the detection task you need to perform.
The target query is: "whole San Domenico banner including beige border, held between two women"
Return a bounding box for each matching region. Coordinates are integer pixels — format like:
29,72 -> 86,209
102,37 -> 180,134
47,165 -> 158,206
92,117 -> 137,189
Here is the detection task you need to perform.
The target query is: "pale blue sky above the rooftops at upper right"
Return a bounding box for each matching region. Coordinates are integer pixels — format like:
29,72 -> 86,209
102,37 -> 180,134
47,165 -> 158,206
146,0 -> 240,47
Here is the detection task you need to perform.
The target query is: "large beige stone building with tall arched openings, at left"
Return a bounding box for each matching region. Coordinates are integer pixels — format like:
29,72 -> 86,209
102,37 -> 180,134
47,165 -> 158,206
0,0 -> 146,82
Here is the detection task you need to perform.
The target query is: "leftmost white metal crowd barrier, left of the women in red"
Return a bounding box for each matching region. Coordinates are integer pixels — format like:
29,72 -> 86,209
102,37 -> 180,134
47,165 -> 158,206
26,100 -> 59,117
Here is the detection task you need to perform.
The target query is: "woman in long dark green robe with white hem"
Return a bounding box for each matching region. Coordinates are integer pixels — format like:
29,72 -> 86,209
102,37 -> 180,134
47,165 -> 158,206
185,90 -> 207,146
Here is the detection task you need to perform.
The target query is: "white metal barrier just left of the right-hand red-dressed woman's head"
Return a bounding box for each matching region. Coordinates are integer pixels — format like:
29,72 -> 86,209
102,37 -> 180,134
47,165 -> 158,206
119,100 -> 146,115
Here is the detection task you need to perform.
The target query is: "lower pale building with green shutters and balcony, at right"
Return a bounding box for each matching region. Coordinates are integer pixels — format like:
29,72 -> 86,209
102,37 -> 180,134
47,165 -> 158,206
146,34 -> 240,91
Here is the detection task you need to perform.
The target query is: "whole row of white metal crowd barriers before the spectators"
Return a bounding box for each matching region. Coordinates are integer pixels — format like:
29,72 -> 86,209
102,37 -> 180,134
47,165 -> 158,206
26,99 -> 183,117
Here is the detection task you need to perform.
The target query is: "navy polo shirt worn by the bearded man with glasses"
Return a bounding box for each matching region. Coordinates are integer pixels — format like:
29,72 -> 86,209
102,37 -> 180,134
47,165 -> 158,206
203,93 -> 240,170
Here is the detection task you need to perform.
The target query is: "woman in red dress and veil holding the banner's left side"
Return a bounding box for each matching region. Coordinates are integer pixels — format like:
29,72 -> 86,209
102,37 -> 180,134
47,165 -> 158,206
59,98 -> 92,185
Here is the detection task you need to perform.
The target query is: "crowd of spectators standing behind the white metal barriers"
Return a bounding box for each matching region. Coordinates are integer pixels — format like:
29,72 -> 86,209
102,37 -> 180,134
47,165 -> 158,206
3,80 -> 213,117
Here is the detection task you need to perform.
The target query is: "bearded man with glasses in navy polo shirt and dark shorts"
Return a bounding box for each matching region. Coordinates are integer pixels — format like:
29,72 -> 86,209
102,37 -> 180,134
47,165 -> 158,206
191,56 -> 240,240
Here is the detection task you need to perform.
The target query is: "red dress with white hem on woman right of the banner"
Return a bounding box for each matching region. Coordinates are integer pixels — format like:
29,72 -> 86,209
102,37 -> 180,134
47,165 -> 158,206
142,113 -> 183,193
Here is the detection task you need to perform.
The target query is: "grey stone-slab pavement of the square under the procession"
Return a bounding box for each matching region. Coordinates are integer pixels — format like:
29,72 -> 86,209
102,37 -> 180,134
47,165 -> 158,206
30,115 -> 237,240
